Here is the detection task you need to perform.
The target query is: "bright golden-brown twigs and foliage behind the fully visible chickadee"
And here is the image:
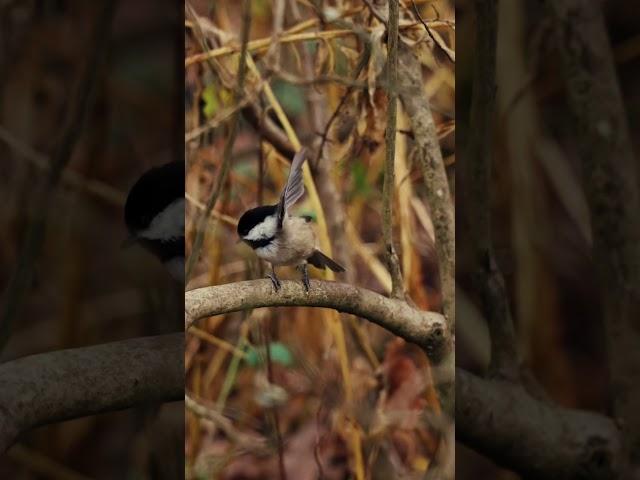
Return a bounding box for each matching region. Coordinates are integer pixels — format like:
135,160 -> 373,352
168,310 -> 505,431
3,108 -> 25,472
185,0 -> 456,480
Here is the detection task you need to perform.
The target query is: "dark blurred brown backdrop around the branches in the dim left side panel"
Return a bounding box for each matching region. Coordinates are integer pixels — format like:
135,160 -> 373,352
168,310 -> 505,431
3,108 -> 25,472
0,0 -> 184,480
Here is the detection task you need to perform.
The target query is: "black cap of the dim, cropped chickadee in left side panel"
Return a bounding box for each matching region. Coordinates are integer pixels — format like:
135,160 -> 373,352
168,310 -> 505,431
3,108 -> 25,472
124,162 -> 185,234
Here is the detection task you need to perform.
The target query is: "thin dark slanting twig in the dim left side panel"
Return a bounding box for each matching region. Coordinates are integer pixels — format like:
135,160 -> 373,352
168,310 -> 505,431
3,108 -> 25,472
0,0 -> 118,351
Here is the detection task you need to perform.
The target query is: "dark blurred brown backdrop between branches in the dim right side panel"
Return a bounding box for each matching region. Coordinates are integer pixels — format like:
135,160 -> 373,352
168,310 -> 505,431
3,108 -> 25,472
456,0 -> 640,479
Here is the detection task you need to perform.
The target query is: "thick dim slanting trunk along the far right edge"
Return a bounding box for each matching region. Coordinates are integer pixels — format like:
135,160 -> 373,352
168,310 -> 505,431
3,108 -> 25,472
547,0 -> 640,472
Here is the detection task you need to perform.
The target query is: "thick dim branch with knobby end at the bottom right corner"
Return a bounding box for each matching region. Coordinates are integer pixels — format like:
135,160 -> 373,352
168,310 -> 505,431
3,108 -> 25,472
456,369 -> 621,480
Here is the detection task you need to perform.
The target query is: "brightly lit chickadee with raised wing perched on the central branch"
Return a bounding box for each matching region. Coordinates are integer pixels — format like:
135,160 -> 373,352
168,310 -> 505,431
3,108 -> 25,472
238,149 -> 344,291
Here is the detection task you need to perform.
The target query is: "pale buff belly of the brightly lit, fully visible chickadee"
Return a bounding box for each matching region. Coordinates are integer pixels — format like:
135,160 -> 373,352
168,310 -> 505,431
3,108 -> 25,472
255,217 -> 316,265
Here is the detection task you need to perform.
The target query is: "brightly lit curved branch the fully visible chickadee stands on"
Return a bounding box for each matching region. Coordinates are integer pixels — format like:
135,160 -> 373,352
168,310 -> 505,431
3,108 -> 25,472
184,280 -> 451,359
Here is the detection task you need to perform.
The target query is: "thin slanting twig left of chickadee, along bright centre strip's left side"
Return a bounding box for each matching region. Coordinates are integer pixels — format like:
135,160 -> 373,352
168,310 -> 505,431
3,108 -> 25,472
185,0 -> 251,282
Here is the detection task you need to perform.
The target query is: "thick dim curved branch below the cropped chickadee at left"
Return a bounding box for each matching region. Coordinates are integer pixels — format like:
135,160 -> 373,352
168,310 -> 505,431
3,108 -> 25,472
0,333 -> 184,453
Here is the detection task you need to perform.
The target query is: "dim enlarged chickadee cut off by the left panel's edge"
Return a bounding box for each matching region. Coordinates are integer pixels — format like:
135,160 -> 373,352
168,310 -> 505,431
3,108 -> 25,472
124,162 -> 185,282
